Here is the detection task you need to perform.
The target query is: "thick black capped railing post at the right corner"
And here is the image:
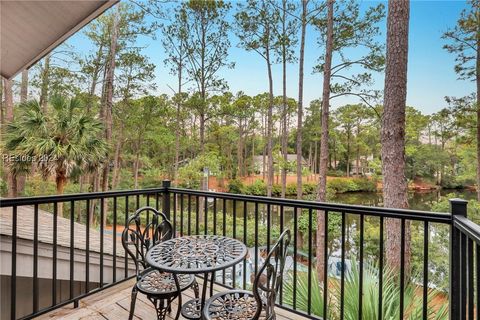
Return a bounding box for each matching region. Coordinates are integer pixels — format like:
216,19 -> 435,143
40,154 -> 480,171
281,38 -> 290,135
449,199 -> 468,319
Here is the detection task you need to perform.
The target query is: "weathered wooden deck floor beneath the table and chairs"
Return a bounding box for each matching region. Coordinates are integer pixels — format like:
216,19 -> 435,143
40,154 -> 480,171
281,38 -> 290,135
35,279 -> 306,320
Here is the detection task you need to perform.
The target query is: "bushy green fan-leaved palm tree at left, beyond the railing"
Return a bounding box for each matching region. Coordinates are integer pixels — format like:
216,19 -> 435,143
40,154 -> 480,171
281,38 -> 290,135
5,96 -> 107,202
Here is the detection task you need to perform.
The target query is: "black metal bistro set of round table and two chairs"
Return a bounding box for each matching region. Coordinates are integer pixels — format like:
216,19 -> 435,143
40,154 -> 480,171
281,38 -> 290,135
122,207 -> 291,320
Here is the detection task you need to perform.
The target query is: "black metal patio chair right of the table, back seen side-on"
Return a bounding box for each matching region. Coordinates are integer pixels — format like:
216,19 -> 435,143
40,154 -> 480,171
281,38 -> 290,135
203,230 -> 291,320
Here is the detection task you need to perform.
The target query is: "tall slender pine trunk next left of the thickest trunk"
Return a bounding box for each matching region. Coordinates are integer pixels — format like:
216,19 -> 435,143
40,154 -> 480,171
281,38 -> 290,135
316,0 -> 335,279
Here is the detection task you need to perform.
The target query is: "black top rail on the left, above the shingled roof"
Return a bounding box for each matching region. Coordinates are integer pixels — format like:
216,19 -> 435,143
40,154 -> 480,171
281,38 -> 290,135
0,187 -> 165,208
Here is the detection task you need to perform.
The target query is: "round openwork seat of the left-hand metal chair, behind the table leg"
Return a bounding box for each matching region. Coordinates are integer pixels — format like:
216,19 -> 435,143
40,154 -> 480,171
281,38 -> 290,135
136,269 -> 195,296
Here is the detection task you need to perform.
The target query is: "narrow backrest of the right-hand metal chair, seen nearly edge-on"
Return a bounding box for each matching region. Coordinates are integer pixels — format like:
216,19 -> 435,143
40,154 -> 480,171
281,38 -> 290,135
253,229 -> 291,320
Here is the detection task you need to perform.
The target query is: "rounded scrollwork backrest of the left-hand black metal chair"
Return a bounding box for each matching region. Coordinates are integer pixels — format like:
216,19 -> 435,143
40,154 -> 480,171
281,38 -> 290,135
122,207 -> 173,276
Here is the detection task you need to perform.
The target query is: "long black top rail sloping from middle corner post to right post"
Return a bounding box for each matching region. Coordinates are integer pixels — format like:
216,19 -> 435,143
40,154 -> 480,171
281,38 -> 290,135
168,188 -> 452,224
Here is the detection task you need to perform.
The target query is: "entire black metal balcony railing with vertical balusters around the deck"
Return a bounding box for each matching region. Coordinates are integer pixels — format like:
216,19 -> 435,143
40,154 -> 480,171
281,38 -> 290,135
0,181 -> 480,319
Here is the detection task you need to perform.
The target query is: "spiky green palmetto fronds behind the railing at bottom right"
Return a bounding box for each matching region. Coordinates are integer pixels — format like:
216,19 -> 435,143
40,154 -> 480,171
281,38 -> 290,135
284,262 -> 448,320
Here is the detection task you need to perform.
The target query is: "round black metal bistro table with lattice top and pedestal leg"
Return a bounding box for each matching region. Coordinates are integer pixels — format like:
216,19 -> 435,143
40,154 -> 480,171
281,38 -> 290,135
146,235 -> 247,319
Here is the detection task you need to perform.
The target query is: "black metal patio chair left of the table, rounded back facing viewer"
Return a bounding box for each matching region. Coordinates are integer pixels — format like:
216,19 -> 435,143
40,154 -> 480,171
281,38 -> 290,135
122,207 -> 198,320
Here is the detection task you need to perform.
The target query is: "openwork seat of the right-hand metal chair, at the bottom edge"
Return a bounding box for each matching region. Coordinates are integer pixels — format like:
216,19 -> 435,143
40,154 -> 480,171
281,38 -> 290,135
203,290 -> 258,320
